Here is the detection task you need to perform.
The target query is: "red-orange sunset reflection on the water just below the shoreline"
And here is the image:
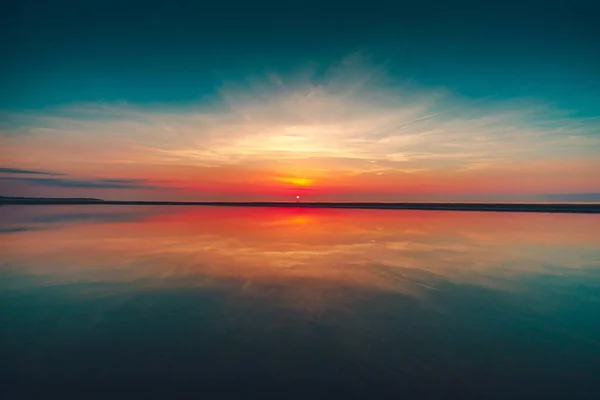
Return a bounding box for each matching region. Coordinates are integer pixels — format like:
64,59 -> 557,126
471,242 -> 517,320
1,206 -> 600,308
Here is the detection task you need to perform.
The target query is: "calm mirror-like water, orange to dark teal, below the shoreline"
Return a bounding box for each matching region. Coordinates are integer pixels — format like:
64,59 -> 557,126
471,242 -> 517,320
0,206 -> 600,399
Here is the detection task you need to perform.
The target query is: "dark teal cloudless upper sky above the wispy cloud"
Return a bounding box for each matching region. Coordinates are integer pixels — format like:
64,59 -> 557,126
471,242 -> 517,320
0,0 -> 600,115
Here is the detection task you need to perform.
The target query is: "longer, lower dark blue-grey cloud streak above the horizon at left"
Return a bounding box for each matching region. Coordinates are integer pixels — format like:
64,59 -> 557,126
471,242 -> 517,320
0,177 -> 167,190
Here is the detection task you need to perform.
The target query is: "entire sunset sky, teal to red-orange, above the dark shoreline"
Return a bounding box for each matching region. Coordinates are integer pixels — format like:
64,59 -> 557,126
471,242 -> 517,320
0,0 -> 600,202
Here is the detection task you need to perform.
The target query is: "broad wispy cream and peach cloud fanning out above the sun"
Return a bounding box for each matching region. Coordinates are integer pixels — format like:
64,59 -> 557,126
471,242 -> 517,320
0,55 -> 600,200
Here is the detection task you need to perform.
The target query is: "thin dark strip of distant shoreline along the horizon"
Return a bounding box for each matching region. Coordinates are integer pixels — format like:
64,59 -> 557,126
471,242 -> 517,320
0,197 -> 600,214
